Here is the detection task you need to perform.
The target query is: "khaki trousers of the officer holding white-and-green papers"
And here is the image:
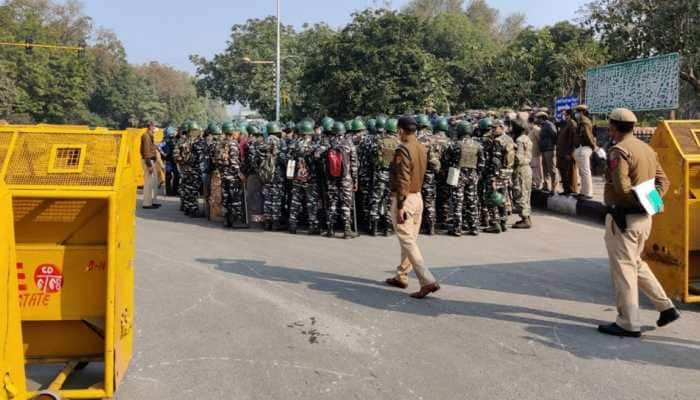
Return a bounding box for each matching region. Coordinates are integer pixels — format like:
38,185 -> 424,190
605,214 -> 673,332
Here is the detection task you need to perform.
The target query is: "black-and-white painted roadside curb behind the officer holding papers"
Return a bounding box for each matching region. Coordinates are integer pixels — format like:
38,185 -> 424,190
531,190 -> 607,224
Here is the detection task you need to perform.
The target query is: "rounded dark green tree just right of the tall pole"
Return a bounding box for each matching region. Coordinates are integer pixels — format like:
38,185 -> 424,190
303,10 -> 453,118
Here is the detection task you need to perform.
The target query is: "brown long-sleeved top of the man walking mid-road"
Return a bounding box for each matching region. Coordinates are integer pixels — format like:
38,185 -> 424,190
389,135 -> 428,209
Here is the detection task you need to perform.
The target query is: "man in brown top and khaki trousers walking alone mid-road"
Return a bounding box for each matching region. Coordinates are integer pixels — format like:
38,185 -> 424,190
386,117 -> 440,299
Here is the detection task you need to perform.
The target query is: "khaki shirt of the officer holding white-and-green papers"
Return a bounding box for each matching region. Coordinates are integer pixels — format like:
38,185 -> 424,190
605,133 -> 669,208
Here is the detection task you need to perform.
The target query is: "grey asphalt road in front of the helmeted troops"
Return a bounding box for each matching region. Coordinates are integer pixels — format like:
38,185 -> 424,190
118,200 -> 700,400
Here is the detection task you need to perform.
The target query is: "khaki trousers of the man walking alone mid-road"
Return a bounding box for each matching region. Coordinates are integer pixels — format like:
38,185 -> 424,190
391,193 -> 435,287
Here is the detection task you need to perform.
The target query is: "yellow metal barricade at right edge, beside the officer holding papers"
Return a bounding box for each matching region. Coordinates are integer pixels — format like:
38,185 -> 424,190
644,121 -> 700,303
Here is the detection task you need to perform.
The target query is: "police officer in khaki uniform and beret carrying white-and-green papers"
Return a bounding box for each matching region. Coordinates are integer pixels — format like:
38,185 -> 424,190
598,108 -> 680,337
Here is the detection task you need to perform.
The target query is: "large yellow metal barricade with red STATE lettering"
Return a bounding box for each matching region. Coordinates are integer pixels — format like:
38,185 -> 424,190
0,126 -> 139,399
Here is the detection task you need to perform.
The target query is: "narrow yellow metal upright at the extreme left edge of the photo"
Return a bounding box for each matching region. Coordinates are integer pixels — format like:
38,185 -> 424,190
0,182 -> 26,400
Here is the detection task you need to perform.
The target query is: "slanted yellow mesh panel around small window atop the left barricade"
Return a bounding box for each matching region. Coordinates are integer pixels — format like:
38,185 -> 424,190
5,132 -> 121,186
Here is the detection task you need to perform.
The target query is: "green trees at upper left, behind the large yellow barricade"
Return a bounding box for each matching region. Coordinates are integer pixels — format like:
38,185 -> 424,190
0,0 -> 223,127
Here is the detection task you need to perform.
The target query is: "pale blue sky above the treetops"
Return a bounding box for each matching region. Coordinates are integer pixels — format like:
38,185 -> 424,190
82,0 -> 589,73
